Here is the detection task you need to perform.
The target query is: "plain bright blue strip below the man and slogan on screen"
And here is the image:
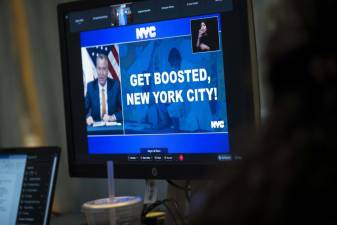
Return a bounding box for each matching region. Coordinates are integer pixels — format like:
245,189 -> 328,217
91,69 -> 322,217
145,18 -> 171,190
88,133 -> 229,154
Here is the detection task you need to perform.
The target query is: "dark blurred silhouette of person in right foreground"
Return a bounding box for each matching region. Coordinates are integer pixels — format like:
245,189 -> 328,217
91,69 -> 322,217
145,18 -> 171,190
190,0 -> 337,225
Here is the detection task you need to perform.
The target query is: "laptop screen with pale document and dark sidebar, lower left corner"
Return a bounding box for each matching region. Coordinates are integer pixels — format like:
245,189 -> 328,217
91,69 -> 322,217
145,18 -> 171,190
0,148 -> 60,225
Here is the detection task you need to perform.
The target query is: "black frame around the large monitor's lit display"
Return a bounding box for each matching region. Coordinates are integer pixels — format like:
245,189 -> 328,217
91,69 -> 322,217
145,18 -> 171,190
58,0 -> 260,179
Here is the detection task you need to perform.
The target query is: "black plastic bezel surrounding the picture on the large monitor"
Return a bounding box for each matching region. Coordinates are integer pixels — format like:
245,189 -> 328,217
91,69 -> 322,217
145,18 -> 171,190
58,0 -> 260,179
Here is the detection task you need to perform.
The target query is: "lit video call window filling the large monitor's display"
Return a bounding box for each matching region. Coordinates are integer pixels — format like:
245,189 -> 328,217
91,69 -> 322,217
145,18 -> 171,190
66,0 -> 232,161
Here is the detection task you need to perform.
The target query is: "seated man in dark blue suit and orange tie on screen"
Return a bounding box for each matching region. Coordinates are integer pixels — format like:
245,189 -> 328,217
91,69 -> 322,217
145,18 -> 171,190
85,54 -> 123,125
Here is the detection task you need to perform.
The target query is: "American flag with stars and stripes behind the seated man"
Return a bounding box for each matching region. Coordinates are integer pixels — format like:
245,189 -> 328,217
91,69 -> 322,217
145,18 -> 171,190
81,45 -> 121,95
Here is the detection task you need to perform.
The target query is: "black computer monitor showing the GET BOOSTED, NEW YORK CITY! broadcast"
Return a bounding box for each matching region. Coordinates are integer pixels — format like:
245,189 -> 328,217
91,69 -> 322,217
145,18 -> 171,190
58,0 -> 258,179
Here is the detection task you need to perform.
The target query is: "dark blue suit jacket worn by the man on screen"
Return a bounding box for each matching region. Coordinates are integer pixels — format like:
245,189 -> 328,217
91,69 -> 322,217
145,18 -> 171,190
85,78 -> 123,121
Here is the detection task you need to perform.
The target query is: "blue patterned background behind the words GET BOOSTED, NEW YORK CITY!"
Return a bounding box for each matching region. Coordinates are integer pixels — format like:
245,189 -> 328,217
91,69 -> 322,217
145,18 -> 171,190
119,36 -> 228,134
